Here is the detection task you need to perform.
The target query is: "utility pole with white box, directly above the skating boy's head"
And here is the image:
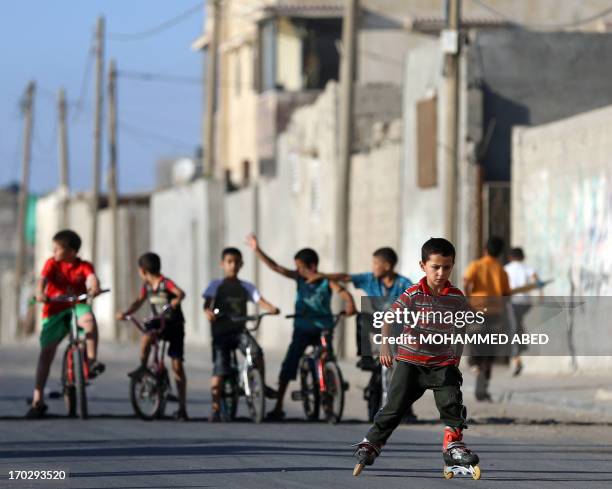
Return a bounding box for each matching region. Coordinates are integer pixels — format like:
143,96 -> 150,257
443,0 -> 461,245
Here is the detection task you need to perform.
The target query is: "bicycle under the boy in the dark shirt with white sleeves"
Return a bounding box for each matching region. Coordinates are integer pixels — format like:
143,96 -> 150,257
214,312 -> 272,423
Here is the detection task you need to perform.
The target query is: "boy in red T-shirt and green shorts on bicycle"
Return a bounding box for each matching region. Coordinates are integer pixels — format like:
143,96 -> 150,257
26,229 -> 104,418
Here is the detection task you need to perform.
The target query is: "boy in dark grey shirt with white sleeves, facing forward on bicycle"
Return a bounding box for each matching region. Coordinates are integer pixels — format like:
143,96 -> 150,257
202,247 -> 280,422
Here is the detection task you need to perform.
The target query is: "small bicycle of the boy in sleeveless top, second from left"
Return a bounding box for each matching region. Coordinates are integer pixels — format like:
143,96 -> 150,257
120,304 -> 172,421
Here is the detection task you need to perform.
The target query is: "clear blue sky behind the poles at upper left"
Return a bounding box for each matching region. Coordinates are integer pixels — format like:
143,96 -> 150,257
0,0 -> 204,194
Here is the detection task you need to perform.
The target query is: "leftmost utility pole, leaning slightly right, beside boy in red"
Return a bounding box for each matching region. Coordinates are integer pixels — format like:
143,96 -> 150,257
15,81 -> 36,332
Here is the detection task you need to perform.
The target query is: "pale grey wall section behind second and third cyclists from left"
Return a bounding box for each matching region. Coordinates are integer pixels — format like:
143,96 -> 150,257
151,179 -> 224,343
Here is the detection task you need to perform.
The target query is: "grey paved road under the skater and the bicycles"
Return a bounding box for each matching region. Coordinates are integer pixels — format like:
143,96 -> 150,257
0,347 -> 612,489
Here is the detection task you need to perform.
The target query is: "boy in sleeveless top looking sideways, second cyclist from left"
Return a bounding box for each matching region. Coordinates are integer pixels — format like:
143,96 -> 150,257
117,252 -> 189,421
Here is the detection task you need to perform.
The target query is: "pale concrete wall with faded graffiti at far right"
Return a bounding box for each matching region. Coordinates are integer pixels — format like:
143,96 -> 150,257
512,107 -> 612,372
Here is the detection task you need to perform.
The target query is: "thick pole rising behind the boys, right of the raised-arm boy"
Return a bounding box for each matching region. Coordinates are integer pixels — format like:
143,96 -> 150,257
334,0 -> 359,356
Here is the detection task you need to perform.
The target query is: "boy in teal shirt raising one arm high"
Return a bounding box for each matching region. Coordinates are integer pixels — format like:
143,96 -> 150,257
247,234 -> 355,420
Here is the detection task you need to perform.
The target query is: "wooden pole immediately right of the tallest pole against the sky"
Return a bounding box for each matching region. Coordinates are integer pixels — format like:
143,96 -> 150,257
108,59 -> 119,339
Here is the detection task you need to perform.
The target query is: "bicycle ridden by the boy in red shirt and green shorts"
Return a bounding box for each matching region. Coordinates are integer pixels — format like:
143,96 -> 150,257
48,289 -> 110,419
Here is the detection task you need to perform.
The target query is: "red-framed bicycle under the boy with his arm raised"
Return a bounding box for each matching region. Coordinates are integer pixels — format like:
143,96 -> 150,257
285,311 -> 349,424
